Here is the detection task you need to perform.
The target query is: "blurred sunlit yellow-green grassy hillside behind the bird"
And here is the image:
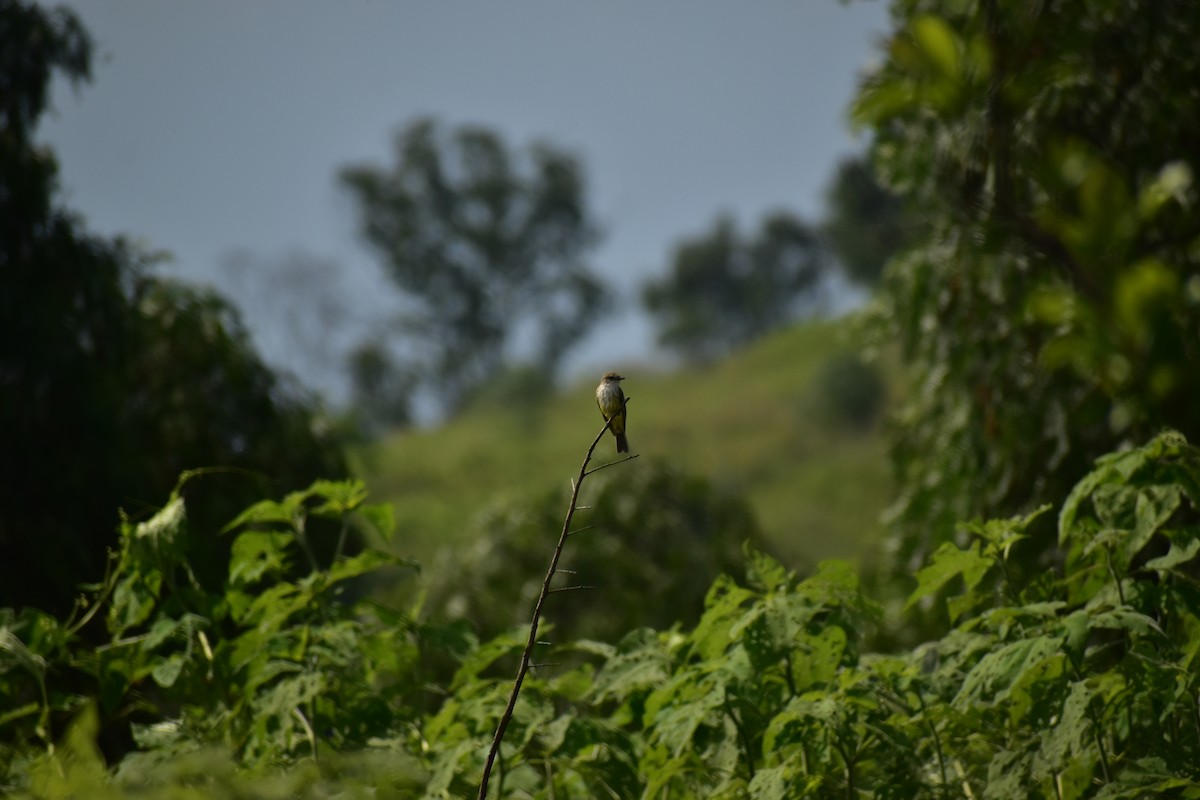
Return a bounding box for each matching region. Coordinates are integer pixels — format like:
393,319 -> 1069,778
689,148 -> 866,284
358,320 -> 892,573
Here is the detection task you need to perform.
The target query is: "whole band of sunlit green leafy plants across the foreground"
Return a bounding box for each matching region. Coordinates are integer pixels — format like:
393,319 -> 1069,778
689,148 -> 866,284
0,433 -> 1200,800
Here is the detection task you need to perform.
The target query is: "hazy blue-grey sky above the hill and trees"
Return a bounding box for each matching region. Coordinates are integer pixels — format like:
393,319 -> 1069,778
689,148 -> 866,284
38,0 -> 887,397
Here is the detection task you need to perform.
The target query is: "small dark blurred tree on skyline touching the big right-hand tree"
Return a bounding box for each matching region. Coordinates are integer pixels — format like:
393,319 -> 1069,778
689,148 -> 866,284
821,157 -> 917,287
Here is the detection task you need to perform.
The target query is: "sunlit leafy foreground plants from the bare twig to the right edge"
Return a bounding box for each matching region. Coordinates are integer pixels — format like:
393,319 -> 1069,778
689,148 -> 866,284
381,434 -> 1200,799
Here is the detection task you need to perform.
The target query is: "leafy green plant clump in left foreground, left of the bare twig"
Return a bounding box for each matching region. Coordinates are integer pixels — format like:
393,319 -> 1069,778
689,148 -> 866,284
0,481 -> 453,794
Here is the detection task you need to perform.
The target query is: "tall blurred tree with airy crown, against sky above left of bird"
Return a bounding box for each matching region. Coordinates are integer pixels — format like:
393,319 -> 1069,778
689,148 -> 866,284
341,119 -> 610,409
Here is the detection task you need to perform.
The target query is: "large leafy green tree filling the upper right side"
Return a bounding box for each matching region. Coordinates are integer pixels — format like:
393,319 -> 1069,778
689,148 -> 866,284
854,0 -> 1200,582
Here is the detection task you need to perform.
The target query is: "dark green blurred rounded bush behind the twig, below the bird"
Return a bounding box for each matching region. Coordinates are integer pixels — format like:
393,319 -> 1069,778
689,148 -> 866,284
427,463 -> 761,642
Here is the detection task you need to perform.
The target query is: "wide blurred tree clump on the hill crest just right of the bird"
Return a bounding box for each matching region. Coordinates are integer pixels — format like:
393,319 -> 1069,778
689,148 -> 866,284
642,212 -> 826,362
